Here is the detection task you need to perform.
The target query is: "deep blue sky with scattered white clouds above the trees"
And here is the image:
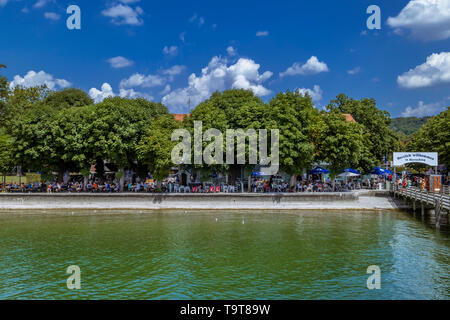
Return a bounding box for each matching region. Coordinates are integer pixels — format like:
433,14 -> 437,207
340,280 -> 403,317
0,0 -> 450,117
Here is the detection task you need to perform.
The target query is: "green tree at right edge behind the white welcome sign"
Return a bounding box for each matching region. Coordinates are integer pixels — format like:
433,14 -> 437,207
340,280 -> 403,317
407,107 -> 450,168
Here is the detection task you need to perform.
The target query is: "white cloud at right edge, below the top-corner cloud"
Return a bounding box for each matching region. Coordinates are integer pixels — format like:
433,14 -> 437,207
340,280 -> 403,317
397,52 -> 450,89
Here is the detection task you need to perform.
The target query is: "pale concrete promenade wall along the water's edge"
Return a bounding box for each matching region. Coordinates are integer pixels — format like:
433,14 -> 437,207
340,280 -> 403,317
0,191 -> 405,211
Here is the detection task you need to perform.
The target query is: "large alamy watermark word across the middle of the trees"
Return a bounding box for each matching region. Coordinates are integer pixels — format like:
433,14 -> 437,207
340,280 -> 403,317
171,121 -> 280,175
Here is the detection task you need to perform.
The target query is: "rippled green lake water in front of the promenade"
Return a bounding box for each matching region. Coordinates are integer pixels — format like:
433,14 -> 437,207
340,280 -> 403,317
0,211 -> 450,299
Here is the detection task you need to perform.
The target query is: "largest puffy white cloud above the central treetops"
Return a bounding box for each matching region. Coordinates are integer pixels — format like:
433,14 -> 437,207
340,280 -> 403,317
162,57 -> 273,112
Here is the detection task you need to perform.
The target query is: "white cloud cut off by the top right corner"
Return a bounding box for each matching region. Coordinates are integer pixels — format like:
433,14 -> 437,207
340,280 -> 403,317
387,0 -> 450,40
